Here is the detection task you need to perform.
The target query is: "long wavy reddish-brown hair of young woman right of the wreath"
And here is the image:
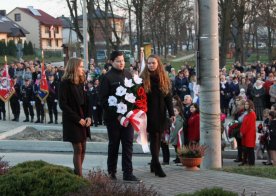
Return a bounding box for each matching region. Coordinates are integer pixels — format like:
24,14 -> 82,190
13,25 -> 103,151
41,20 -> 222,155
141,54 -> 171,95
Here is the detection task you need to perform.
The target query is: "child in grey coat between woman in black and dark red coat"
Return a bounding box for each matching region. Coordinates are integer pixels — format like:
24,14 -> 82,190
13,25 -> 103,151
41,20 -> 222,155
170,106 -> 184,163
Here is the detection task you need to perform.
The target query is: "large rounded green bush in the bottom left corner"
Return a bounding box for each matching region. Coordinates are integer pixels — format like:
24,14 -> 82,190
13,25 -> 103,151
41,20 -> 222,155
0,161 -> 89,196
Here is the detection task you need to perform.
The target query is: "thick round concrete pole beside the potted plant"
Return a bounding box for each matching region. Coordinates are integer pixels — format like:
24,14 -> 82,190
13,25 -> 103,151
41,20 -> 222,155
197,0 -> 222,169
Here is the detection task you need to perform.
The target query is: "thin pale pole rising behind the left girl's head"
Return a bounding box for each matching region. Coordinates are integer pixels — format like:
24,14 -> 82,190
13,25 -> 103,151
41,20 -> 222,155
82,0 -> 88,70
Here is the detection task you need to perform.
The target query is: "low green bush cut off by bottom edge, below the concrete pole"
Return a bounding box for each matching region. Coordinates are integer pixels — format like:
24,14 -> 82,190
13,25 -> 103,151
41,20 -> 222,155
177,187 -> 238,196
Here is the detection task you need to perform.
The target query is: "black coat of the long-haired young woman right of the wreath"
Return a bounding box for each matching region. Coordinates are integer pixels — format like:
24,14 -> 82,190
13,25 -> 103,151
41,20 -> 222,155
147,77 -> 174,133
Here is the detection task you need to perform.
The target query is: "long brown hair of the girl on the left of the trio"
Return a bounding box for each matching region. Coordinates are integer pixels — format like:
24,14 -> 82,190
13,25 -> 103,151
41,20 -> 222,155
61,58 -> 85,84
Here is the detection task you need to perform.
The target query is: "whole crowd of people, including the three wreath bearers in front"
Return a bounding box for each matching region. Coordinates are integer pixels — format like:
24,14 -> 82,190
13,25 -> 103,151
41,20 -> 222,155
0,51 -> 276,181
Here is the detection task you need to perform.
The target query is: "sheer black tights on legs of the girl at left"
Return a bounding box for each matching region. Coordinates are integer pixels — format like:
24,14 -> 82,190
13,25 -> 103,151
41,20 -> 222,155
72,141 -> 86,176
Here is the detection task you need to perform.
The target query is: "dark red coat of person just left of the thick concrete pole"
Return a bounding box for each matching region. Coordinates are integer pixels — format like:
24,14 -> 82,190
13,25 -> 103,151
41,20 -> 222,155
187,113 -> 199,141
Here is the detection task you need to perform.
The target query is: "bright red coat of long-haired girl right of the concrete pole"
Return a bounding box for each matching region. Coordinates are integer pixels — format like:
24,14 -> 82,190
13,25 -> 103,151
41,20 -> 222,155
240,111 -> 256,148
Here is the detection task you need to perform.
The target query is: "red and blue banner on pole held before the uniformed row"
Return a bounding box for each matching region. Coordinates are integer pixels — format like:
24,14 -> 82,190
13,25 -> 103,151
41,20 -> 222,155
37,51 -> 49,101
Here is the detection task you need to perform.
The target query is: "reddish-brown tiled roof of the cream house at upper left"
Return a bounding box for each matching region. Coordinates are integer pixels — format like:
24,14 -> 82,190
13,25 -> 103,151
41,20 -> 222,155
18,7 -> 62,25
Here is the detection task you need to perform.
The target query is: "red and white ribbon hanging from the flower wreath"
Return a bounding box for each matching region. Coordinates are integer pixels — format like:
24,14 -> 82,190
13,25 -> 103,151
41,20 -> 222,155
126,109 -> 150,153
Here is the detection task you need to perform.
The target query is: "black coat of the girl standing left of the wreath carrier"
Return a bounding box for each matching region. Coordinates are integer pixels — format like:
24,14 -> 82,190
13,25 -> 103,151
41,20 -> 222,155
59,80 -> 91,142
